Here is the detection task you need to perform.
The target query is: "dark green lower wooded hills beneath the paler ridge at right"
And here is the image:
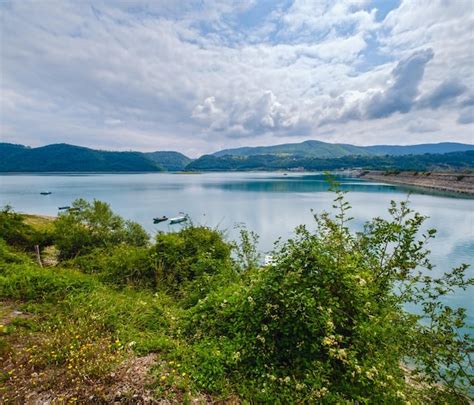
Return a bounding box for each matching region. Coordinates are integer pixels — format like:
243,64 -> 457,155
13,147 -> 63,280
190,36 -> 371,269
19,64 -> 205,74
187,150 -> 474,171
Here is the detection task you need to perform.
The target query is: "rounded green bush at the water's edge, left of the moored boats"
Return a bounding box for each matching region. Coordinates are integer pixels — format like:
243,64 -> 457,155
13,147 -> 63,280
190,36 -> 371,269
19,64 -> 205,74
54,199 -> 149,259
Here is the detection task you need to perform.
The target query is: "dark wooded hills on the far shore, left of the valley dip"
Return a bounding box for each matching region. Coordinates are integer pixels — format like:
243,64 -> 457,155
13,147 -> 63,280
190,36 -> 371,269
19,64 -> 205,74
0,143 -> 189,172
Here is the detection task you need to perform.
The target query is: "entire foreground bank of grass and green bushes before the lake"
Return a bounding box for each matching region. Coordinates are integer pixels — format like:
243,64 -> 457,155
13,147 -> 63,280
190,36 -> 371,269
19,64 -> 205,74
0,192 -> 473,404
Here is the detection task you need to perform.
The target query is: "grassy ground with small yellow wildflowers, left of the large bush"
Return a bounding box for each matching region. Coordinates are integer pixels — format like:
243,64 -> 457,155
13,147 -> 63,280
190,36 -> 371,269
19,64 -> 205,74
0,263 -> 189,402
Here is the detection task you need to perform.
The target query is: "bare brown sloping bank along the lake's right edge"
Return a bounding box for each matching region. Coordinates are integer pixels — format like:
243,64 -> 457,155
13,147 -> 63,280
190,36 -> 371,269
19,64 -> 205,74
356,170 -> 474,196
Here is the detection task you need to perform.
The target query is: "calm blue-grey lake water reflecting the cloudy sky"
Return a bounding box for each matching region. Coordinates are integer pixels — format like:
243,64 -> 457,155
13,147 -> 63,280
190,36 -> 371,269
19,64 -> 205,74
0,173 -> 474,325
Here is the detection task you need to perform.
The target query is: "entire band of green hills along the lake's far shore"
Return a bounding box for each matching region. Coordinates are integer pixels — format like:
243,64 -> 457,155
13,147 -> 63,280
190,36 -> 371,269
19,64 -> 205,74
0,141 -> 474,172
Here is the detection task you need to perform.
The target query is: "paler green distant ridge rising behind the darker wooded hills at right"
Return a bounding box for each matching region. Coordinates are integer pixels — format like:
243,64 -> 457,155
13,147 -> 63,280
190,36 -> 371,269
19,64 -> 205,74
213,141 -> 474,158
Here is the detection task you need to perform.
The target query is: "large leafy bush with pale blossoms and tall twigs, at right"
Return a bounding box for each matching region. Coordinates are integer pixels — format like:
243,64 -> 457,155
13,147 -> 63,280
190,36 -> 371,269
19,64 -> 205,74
186,195 -> 472,403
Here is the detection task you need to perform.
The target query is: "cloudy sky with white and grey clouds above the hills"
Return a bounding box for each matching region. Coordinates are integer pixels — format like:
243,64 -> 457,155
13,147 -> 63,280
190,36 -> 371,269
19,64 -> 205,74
0,0 -> 474,156
